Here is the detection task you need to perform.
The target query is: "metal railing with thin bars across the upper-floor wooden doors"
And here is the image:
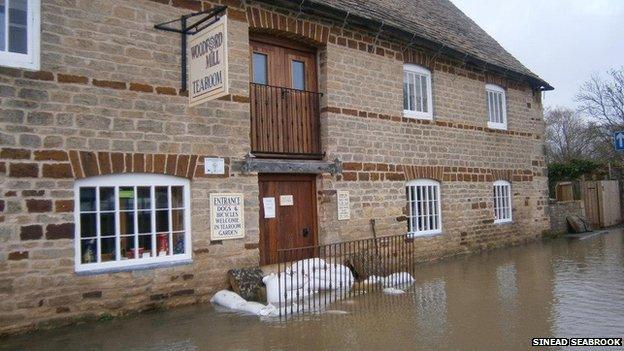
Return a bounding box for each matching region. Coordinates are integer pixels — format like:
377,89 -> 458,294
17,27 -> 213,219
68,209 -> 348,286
249,83 -> 322,156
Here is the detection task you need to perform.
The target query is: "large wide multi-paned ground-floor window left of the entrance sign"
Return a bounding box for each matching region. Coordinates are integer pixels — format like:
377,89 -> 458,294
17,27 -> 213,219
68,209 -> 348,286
74,174 -> 191,271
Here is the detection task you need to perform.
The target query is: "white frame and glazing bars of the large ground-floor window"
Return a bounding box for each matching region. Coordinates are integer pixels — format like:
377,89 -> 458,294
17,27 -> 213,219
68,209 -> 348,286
74,173 -> 192,272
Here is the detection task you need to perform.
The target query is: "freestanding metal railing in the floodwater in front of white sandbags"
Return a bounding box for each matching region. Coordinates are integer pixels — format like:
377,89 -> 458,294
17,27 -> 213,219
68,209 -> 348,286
274,234 -> 416,319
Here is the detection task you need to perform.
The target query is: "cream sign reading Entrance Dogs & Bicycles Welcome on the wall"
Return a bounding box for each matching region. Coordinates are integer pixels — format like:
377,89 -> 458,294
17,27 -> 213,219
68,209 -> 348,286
210,193 -> 245,240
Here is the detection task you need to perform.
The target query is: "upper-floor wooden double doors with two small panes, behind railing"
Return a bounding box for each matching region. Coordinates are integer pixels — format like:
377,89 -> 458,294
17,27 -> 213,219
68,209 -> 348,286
250,39 -> 320,158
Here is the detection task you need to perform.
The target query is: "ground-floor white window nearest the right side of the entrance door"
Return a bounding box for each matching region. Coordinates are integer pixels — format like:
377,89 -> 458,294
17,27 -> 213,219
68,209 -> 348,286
405,179 -> 442,236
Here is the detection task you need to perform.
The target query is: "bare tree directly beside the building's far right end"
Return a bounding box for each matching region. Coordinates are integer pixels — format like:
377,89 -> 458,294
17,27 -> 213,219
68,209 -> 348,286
545,107 -> 596,163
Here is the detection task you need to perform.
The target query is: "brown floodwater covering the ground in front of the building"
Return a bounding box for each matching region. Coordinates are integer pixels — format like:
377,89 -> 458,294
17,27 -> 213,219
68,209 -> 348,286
0,229 -> 624,351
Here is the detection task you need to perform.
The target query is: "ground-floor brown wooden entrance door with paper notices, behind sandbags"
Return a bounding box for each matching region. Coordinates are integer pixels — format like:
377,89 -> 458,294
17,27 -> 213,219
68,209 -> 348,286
258,174 -> 317,264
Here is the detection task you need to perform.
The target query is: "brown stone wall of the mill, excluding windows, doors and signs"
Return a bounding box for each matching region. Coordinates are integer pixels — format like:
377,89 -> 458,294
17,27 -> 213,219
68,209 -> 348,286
0,0 -> 549,334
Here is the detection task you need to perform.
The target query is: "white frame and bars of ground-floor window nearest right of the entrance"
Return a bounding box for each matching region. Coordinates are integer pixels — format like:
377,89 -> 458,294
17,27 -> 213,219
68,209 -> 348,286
405,179 -> 442,237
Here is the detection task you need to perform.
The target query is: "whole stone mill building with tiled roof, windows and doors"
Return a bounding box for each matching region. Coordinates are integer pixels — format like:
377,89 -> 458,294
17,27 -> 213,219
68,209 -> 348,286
0,0 -> 552,334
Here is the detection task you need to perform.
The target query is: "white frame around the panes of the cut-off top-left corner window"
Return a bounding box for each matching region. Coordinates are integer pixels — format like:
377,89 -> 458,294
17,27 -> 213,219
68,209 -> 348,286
0,0 -> 41,71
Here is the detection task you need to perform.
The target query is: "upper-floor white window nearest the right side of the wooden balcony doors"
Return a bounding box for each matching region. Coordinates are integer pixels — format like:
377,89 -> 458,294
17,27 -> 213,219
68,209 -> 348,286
403,65 -> 433,119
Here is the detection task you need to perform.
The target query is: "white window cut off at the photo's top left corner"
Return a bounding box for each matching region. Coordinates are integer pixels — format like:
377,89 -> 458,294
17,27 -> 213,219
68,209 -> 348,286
0,0 -> 40,70
